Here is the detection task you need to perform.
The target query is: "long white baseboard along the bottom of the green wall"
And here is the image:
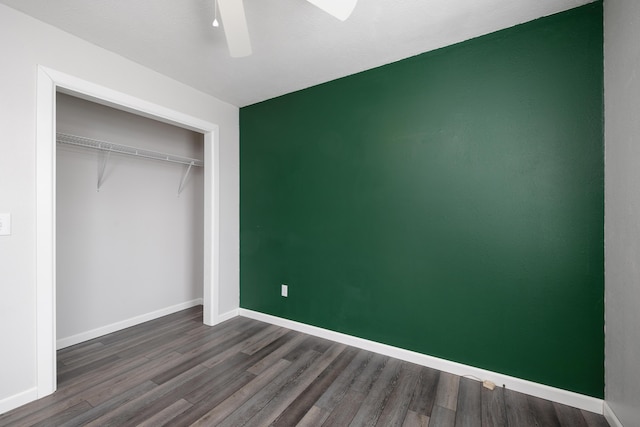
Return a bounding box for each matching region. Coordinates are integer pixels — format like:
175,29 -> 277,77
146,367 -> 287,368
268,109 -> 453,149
238,308 -> 604,414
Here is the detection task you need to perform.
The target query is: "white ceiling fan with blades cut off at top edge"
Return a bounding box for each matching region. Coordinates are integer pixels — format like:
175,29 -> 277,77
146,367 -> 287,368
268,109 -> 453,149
213,0 -> 358,58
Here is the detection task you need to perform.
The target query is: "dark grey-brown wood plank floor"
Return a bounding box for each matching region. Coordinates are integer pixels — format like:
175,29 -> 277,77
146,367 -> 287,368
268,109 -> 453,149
0,307 -> 607,427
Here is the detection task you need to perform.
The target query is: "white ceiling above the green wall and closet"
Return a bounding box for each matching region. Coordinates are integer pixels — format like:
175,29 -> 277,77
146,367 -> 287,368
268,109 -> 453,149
0,0 -> 593,107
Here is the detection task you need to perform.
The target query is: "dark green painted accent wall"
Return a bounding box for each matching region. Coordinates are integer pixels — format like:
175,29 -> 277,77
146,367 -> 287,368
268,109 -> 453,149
240,2 -> 604,398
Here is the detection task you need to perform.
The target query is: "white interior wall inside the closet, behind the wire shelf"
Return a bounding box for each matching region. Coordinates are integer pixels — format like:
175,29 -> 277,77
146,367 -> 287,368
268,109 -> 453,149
56,94 -> 204,346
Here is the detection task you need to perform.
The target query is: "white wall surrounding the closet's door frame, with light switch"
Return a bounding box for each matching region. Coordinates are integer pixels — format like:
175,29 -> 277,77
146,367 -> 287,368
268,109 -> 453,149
0,5 -> 239,412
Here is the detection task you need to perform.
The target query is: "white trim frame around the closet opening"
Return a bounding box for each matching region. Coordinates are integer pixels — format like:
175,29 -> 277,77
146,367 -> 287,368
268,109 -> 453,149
35,66 -> 220,398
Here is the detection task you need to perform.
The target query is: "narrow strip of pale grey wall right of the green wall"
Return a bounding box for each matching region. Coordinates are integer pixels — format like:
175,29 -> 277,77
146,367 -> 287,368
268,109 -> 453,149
604,0 -> 640,427
